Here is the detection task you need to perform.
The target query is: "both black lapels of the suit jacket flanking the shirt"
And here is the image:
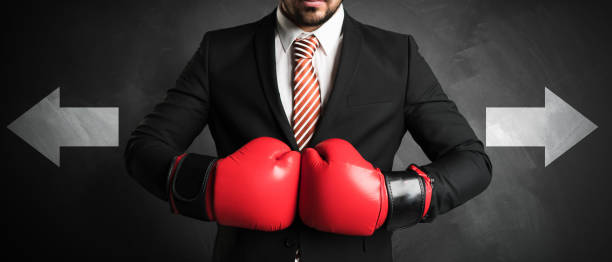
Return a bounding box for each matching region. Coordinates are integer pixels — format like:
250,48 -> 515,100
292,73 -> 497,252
255,8 -> 362,150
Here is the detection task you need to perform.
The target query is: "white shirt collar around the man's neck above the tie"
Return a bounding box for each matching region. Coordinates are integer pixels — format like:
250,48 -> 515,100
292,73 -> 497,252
276,4 -> 344,55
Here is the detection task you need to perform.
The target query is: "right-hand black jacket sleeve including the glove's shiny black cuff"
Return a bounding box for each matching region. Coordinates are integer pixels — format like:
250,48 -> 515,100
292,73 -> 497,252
385,36 -> 492,229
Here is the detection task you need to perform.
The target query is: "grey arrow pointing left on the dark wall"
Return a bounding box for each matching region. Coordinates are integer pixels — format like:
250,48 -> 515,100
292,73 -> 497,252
8,87 -> 119,166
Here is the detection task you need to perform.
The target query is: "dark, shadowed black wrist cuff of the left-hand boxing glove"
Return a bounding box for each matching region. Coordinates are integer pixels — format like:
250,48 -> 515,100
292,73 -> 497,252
167,154 -> 216,221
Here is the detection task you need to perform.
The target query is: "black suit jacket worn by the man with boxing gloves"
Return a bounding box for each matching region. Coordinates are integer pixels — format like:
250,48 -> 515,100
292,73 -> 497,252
125,6 -> 491,262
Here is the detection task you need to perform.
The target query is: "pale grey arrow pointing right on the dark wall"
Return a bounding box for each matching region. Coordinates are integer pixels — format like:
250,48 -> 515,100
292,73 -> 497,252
486,87 -> 597,166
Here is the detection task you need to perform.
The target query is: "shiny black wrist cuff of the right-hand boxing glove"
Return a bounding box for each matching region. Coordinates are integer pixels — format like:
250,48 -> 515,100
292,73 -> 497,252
384,165 -> 432,230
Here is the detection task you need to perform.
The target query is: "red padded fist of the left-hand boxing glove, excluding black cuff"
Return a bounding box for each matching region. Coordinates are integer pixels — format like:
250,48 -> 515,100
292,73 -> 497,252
207,137 -> 300,231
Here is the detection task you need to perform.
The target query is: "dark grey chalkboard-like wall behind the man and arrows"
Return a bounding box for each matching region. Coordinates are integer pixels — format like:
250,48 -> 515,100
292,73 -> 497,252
0,0 -> 612,261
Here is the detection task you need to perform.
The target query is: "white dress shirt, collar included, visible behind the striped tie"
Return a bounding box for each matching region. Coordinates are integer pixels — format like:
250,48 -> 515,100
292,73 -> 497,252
274,4 -> 344,125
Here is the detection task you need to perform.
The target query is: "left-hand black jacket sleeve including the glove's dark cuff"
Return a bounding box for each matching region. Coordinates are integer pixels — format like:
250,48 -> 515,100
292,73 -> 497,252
125,31 -> 215,220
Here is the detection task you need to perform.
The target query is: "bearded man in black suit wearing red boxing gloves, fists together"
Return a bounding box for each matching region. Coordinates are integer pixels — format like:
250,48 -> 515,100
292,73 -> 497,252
125,0 -> 491,262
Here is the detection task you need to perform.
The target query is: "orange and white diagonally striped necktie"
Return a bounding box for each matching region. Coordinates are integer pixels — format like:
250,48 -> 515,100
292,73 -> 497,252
292,35 -> 321,151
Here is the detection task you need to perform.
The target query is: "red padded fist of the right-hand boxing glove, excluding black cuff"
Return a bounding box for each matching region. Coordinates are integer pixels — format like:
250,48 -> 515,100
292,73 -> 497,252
299,138 -> 388,236
